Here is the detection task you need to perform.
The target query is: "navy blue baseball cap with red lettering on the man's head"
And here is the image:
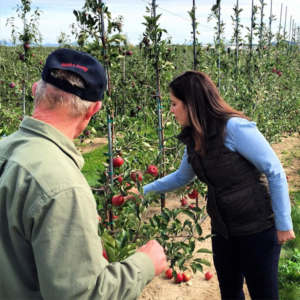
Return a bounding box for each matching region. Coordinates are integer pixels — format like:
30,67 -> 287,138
42,49 -> 107,102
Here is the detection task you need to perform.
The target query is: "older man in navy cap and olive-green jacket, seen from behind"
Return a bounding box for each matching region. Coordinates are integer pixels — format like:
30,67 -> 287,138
0,49 -> 166,300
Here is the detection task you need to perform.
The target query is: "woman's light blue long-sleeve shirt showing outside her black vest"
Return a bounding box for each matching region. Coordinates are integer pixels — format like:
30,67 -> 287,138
144,117 -> 293,231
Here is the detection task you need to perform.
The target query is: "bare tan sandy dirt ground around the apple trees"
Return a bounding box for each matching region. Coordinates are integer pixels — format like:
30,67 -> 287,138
78,135 -> 300,300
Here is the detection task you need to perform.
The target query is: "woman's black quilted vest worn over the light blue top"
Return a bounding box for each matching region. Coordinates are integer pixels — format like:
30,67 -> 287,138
177,119 -> 275,238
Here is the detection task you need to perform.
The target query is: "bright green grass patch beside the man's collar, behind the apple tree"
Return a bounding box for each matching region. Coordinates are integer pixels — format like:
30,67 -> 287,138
82,145 -> 108,187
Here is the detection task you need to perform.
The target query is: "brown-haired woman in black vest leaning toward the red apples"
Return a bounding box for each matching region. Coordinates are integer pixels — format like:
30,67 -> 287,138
131,71 -> 295,299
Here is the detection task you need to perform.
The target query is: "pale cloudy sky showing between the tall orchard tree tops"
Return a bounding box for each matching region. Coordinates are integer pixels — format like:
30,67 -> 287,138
0,0 -> 300,45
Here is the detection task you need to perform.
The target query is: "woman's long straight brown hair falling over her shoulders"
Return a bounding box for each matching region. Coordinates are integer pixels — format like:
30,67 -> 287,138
169,71 -> 249,156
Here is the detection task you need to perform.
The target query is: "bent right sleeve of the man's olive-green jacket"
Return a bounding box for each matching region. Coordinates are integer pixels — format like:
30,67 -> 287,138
27,188 -> 155,300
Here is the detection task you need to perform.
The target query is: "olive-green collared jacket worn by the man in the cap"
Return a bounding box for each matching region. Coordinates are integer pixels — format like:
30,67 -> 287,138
0,117 -> 155,300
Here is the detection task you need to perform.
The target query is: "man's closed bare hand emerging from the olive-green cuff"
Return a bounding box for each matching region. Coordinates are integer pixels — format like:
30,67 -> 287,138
137,240 -> 168,276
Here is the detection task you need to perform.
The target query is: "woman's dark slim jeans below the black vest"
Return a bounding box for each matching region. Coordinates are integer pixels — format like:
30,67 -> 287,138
212,227 -> 281,300
